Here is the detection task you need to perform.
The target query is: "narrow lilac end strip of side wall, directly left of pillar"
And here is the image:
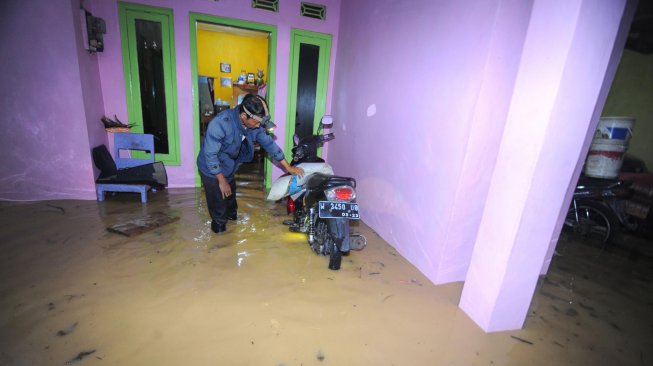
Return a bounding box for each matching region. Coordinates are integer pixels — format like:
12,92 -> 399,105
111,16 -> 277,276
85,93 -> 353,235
430,0 -> 532,282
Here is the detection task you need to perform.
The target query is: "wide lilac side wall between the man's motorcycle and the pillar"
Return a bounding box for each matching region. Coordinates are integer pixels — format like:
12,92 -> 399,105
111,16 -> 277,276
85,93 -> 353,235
329,0 -> 530,283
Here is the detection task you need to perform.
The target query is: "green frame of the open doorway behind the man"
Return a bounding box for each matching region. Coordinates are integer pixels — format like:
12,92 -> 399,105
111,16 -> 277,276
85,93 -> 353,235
189,13 -> 277,188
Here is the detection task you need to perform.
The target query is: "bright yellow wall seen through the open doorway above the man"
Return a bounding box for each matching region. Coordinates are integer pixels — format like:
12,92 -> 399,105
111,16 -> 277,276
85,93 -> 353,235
197,30 -> 268,107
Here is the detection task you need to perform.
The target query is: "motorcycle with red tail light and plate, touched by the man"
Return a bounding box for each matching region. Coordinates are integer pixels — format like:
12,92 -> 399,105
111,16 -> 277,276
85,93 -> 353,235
267,116 -> 367,270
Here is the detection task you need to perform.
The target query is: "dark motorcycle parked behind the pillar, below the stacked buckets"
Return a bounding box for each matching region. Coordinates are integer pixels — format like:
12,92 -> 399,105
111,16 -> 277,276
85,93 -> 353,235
564,176 -> 650,248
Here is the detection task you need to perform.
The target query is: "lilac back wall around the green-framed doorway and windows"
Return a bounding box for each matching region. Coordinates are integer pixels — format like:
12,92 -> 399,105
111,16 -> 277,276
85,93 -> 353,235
86,0 -> 340,187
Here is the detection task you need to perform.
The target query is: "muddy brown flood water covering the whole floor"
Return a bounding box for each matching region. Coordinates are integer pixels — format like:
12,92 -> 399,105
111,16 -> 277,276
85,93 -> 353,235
0,167 -> 653,366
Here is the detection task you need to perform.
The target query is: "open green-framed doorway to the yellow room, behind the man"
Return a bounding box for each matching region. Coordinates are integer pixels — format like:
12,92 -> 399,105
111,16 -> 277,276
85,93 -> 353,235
190,14 -> 276,186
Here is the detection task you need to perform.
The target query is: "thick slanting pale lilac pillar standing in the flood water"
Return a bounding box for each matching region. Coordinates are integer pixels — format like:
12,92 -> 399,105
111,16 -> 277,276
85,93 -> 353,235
460,0 -> 634,332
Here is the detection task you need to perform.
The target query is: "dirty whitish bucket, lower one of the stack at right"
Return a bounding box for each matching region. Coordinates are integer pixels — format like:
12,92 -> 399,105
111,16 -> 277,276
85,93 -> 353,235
583,138 -> 628,179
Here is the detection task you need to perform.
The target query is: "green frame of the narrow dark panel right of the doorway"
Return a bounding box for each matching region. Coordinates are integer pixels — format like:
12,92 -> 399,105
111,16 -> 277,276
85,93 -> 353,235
284,28 -> 332,161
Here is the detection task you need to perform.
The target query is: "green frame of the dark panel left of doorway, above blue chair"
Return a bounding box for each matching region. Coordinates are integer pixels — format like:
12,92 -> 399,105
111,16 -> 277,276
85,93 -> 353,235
118,2 -> 181,165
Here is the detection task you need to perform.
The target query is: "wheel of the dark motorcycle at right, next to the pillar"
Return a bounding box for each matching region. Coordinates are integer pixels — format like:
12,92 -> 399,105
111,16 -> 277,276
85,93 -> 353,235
565,200 -> 619,248
